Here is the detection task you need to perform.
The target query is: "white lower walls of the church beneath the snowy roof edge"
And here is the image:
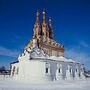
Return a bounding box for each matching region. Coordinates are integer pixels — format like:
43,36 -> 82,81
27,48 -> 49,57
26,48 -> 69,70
11,59 -> 83,82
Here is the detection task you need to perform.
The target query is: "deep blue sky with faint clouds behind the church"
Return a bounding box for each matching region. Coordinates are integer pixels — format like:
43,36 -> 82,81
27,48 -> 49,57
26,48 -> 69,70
0,0 -> 90,69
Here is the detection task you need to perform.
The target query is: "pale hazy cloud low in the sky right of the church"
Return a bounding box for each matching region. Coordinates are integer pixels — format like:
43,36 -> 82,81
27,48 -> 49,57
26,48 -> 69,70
65,47 -> 90,68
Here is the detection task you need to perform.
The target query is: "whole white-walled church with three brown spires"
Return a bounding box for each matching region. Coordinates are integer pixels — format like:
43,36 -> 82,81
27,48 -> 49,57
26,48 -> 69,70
11,11 -> 85,82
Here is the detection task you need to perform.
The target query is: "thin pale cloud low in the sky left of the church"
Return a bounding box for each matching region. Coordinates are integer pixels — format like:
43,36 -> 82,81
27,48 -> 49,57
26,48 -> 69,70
0,46 -> 20,57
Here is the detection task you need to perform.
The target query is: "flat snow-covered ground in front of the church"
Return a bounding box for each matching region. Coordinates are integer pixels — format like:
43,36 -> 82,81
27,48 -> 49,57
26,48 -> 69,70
0,76 -> 90,90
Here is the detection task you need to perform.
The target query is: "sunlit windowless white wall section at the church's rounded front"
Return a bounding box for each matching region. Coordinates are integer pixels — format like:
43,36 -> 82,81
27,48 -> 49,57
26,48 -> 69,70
13,60 -> 51,82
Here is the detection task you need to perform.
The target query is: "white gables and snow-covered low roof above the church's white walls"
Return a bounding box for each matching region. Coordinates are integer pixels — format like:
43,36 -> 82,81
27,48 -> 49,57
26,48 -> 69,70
18,39 -> 78,63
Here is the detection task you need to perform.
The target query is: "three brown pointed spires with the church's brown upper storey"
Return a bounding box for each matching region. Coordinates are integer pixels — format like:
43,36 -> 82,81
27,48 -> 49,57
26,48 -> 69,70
25,11 -> 64,56
